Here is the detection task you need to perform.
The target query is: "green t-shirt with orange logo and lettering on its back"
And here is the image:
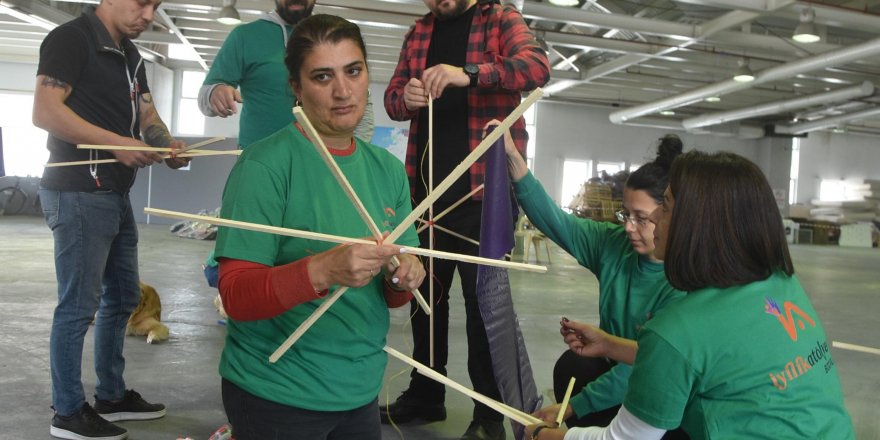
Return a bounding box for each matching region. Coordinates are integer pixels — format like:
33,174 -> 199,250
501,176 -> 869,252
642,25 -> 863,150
623,273 -> 855,440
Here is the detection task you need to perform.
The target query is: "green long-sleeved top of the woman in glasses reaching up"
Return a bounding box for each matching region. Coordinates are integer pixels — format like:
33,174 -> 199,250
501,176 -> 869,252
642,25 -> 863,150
514,173 -> 684,416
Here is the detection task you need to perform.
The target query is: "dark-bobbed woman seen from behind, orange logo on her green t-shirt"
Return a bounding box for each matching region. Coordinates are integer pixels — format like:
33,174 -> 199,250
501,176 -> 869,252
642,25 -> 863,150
527,151 -> 855,440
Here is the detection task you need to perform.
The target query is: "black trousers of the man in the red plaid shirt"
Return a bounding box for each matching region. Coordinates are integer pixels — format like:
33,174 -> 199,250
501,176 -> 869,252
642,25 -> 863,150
409,202 -> 503,421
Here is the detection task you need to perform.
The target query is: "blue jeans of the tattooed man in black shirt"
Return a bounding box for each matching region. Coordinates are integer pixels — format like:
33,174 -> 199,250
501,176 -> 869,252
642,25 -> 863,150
40,189 -> 140,416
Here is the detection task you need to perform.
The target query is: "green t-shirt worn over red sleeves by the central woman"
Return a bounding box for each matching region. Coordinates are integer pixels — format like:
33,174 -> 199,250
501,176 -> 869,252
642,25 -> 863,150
216,124 -> 419,411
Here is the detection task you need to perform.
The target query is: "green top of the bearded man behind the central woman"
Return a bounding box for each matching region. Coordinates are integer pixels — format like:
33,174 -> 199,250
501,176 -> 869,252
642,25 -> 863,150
204,19 -> 294,147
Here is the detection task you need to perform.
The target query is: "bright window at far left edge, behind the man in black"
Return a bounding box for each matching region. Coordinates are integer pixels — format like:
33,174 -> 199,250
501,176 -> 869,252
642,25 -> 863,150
0,92 -> 49,177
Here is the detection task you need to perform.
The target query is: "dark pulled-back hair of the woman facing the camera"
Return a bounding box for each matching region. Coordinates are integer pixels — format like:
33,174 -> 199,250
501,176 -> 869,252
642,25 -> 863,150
284,14 -> 367,84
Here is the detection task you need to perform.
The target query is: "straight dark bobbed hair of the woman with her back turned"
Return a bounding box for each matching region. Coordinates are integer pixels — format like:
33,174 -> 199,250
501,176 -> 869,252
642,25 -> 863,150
664,151 -> 794,292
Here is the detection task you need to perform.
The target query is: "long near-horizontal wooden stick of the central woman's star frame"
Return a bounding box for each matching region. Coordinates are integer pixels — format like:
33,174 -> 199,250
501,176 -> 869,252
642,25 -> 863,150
144,208 -> 547,273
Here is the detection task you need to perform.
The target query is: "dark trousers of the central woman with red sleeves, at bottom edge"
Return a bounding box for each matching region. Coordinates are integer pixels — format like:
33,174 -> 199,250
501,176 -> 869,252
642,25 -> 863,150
222,379 -> 382,440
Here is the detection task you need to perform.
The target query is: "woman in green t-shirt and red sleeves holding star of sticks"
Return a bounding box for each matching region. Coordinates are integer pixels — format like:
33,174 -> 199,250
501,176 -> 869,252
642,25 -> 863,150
216,15 -> 425,440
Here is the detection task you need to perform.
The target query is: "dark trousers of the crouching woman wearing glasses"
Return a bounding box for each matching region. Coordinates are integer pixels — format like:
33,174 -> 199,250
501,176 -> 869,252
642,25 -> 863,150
553,350 -> 690,440
